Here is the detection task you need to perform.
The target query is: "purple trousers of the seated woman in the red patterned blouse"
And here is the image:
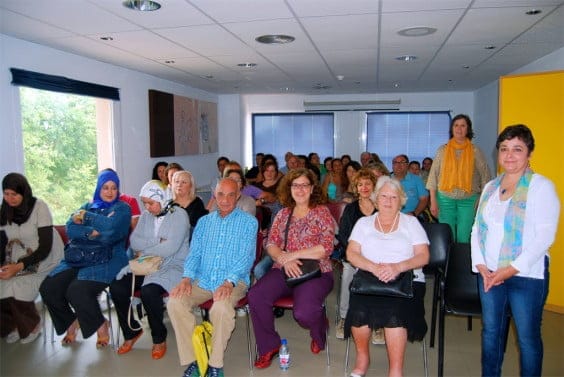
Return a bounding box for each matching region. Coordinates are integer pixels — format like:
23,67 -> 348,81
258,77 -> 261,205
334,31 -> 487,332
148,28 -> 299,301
248,268 -> 333,355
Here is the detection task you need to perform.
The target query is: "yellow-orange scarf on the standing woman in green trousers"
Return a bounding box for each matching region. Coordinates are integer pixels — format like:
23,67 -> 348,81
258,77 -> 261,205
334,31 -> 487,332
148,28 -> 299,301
439,139 -> 474,194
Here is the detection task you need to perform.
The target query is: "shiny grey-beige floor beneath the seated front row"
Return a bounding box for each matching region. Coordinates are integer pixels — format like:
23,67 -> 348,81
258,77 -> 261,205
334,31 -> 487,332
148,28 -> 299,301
0,274 -> 564,377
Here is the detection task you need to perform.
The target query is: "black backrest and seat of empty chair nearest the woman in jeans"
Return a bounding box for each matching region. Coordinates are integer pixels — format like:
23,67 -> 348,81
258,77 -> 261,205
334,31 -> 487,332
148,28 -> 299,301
444,243 -> 482,316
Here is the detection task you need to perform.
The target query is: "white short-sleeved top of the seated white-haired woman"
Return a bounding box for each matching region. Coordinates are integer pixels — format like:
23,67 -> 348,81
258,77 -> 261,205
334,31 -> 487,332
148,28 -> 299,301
349,213 -> 429,282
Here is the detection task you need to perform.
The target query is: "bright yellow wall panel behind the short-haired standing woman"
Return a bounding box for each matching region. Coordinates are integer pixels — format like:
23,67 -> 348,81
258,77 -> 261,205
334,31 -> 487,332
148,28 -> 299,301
499,71 -> 564,313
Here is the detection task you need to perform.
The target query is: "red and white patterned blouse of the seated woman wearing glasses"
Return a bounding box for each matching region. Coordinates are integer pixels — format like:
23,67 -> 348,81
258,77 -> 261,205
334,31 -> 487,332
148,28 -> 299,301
266,205 -> 335,272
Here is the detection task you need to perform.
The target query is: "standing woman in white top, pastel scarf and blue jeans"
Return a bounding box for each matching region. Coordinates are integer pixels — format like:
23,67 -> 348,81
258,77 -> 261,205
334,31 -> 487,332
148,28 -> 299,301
471,125 -> 560,376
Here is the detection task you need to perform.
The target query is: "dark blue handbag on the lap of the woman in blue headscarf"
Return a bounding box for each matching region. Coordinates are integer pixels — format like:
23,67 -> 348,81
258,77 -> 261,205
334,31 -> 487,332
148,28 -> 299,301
65,240 -> 112,268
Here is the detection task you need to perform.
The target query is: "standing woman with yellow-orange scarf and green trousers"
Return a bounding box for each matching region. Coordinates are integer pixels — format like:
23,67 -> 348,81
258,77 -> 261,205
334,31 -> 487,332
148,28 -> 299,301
427,114 -> 491,242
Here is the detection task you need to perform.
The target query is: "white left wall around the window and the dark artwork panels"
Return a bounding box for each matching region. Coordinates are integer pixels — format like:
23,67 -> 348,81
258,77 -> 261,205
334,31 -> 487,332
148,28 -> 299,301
0,34 -> 219,196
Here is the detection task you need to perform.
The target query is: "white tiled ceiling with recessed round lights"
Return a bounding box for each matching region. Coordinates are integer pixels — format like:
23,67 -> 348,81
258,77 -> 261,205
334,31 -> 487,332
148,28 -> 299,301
0,0 -> 564,95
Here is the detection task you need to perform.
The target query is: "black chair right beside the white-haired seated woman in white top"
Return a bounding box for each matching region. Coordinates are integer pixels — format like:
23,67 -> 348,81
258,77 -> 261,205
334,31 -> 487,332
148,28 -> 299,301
423,223 -> 453,347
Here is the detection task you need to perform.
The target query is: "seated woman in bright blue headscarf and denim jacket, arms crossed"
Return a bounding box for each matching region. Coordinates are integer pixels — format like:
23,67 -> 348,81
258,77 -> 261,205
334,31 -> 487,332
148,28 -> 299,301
39,171 -> 131,348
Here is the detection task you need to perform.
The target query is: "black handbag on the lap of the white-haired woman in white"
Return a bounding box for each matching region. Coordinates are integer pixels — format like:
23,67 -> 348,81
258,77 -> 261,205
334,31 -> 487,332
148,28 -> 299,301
349,269 -> 413,298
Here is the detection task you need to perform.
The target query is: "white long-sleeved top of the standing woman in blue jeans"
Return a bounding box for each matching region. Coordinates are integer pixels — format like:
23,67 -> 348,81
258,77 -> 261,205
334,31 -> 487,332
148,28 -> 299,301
471,174 -> 560,279
